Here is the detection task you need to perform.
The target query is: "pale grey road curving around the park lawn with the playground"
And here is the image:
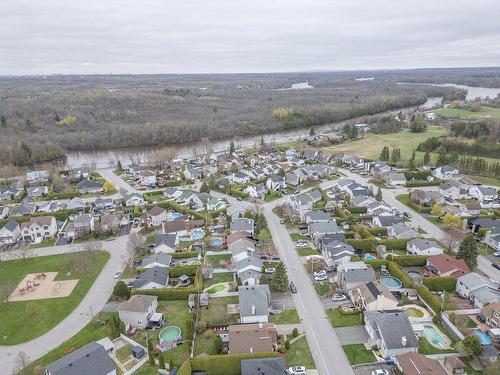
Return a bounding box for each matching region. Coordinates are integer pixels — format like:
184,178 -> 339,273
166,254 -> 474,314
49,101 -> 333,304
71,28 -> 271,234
0,236 -> 128,374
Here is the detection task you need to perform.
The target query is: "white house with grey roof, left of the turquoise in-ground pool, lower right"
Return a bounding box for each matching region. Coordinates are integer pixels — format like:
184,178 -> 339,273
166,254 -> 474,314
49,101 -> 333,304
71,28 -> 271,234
365,310 -> 418,358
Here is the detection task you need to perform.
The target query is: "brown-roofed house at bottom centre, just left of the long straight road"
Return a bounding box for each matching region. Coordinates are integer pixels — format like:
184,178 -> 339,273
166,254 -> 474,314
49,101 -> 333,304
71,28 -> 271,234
229,323 -> 278,354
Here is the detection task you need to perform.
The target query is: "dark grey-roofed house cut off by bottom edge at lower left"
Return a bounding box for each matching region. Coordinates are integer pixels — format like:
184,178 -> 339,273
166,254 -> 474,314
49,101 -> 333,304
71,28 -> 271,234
45,342 -> 117,375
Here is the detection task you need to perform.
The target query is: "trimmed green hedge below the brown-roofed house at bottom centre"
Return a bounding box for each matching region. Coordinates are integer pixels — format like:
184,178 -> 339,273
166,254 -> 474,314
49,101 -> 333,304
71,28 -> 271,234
191,352 -> 279,375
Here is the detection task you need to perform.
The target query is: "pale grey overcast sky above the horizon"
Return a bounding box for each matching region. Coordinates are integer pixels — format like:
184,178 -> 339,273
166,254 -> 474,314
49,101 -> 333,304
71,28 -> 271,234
0,0 -> 500,75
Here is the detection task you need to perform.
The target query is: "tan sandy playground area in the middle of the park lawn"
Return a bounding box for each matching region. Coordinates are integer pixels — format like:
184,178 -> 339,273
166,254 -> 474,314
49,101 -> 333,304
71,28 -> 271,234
9,272 -> 78,302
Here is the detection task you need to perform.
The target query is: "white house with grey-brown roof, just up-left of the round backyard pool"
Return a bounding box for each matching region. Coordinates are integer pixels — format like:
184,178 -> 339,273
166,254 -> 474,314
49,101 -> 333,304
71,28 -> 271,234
118,294 -> 163,331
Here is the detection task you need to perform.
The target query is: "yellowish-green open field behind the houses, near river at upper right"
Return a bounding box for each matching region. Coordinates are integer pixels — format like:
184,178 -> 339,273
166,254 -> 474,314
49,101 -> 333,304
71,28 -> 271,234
322,126 -> 448,160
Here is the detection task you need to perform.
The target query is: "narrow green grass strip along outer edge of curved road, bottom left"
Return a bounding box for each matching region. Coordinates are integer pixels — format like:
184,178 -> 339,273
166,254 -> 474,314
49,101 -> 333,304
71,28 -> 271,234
25,313 -> 111,375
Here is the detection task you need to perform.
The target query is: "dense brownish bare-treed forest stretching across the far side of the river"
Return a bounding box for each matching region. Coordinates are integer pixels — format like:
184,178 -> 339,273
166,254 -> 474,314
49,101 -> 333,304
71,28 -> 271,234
0,72 -> 488,165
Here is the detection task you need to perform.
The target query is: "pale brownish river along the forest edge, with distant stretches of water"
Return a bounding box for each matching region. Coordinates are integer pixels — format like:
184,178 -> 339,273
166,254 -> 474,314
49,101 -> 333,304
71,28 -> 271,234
65,82 -> 500,168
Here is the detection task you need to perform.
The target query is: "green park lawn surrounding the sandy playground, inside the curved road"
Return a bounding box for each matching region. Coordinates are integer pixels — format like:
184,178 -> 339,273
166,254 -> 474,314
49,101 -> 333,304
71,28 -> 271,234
0,251 -> 109,345
